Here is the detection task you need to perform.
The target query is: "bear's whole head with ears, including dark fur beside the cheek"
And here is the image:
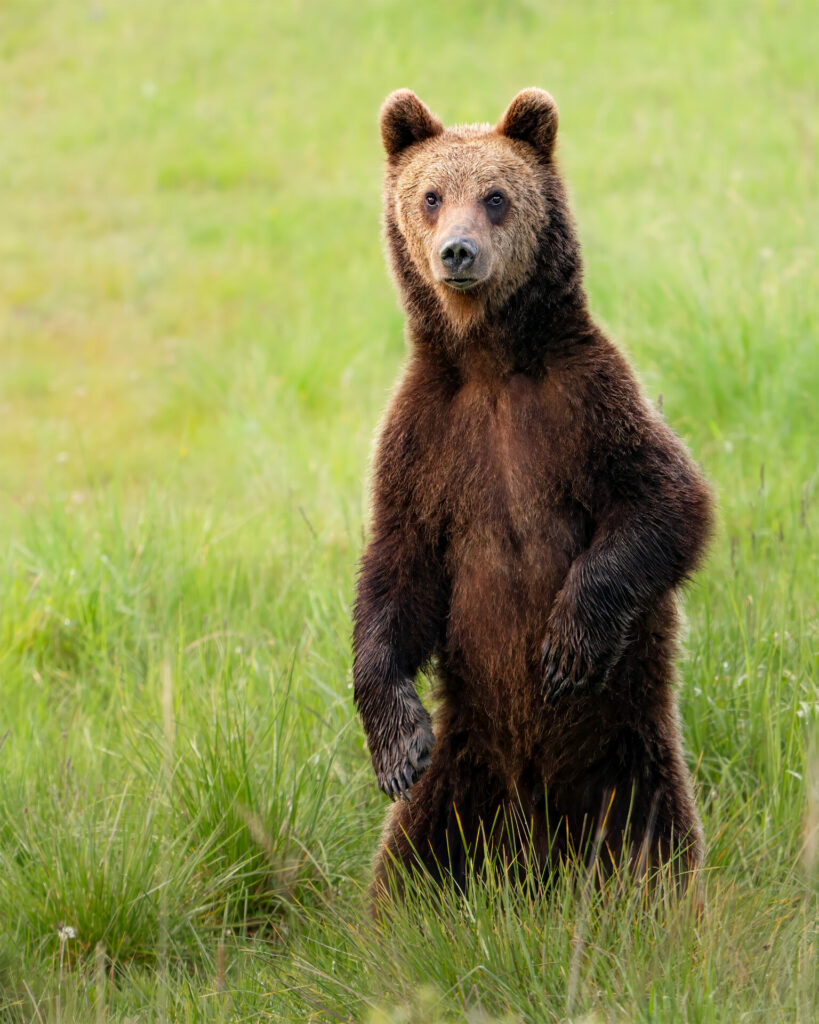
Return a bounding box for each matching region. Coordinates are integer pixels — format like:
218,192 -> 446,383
381,89 -> 580,334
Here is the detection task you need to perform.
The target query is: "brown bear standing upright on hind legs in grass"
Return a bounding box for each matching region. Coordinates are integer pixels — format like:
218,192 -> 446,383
353,89 -> 712,894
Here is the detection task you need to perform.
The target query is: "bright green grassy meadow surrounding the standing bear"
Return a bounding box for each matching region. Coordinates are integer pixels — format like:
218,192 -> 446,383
0,0 -> 819,1024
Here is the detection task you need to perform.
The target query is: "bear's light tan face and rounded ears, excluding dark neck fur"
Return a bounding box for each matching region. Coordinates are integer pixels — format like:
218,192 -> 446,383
381,89 -> 557,327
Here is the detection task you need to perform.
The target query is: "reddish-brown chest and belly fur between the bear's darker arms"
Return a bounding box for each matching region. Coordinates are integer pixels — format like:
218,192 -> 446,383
436,375 -> 593,736
